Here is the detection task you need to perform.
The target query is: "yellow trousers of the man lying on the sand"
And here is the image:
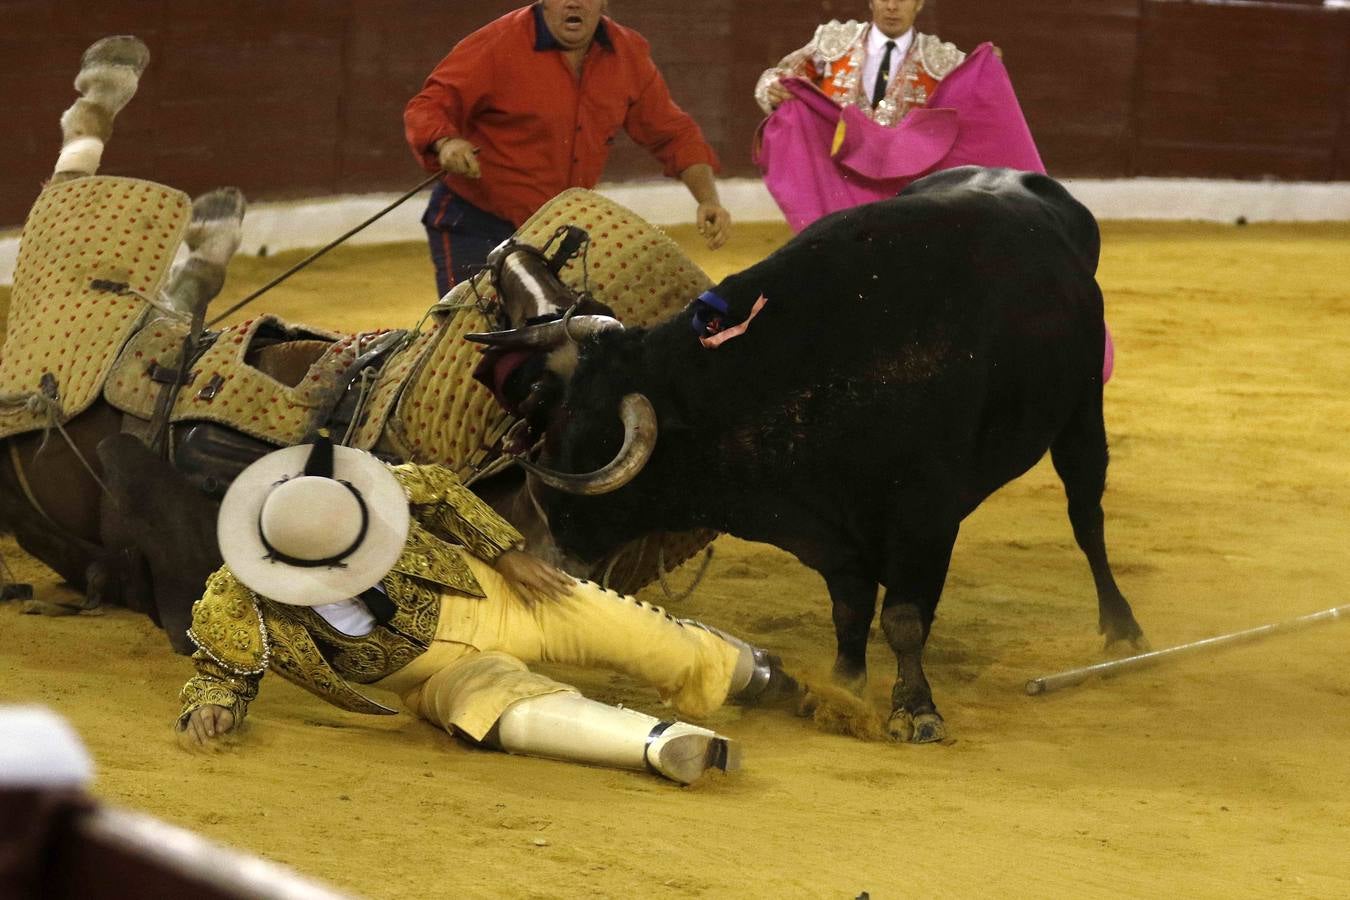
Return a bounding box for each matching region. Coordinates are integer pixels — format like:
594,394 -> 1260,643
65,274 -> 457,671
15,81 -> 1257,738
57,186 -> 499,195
375,553 -> 740,741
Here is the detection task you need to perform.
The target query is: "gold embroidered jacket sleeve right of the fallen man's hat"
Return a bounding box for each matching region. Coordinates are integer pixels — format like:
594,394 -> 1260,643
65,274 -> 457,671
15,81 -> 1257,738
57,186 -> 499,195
394,464 -> 525,563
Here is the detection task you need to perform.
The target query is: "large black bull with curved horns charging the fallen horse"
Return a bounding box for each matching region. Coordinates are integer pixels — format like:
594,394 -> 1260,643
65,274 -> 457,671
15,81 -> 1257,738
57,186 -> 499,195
510,169 -> 1143,741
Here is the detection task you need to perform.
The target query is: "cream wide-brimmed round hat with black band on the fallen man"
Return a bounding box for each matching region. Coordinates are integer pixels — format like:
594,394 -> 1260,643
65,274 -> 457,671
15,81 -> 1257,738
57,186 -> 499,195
217,439 -> 410,606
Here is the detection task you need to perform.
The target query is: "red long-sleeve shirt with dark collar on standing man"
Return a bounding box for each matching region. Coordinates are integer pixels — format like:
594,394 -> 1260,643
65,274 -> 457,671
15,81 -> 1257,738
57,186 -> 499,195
404,5 -> 717,225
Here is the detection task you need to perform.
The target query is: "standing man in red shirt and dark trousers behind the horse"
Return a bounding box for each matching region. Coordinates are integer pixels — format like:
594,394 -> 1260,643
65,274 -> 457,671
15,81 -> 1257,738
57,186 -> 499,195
404,0 -> 732,296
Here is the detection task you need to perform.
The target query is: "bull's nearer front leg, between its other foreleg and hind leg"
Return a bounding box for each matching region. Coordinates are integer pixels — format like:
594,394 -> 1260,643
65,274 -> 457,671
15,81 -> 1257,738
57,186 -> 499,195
882,526 -> 957,743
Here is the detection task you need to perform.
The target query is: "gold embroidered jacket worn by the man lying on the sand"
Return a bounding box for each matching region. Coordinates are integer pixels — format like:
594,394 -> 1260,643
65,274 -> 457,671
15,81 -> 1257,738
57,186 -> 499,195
178,464 -> 522,725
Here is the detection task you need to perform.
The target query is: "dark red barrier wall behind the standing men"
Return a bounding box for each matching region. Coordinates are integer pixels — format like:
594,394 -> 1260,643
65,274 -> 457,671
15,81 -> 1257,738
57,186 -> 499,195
0,0 -> 1350,224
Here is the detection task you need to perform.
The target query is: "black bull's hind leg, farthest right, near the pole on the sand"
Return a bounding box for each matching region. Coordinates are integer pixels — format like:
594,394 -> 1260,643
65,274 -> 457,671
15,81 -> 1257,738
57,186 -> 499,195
1050,393 -> 1149,652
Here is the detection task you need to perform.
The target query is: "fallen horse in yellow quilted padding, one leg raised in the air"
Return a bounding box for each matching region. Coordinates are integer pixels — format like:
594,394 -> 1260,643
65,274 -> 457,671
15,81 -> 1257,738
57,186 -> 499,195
0,36 -> 711,652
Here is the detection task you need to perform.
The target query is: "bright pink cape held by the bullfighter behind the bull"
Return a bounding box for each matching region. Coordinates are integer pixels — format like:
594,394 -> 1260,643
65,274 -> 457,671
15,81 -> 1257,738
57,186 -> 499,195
755,43 -> 1115,383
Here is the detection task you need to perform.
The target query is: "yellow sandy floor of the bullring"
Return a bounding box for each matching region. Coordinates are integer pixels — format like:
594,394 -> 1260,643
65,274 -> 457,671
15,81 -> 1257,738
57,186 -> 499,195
0,214 -> 1350,900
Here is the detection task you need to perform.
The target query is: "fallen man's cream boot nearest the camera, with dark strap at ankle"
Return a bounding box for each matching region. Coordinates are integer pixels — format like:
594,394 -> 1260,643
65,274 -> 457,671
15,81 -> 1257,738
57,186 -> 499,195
487,692 -> 740,784
